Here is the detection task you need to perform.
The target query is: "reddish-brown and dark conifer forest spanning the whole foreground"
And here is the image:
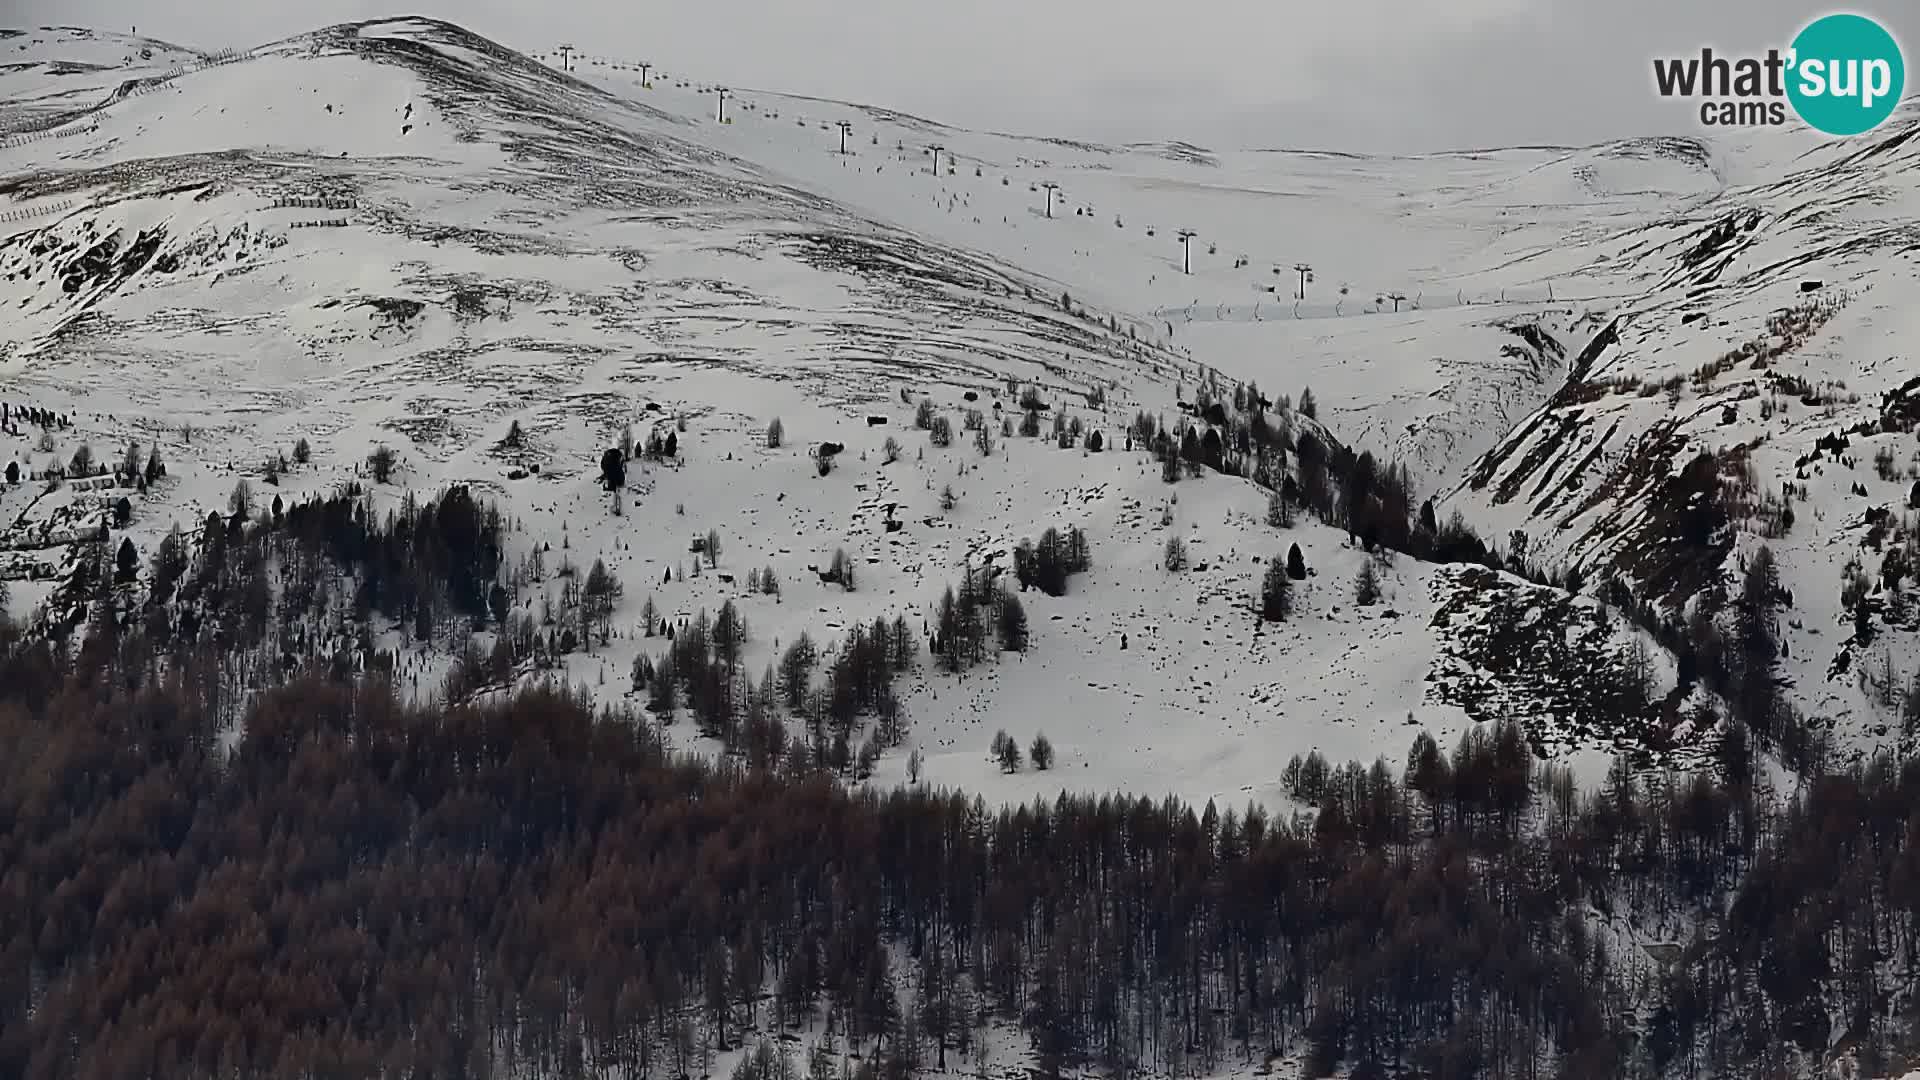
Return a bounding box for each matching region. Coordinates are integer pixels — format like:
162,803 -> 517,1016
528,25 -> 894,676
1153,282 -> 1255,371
0,478 -> 1920,1080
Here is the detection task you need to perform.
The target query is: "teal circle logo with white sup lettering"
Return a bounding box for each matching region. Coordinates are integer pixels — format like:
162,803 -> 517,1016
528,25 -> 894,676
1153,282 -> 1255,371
1788,15 -> 1907,135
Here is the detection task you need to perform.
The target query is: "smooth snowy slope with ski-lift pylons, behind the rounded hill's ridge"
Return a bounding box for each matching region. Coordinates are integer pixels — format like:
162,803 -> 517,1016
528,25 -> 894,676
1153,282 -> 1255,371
576,68 -> 1722,484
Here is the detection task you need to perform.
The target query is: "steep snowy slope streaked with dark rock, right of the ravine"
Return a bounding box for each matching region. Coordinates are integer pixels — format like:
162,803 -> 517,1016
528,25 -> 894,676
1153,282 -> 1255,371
1448,102 -> 1920,744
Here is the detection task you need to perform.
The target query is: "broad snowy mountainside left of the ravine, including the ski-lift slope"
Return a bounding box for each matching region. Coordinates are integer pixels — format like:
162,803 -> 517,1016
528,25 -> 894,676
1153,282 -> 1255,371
0,19 -> 1891,801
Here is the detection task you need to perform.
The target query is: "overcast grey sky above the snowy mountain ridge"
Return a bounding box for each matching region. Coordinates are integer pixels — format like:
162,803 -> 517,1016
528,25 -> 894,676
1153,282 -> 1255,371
0,0 -> 1920,152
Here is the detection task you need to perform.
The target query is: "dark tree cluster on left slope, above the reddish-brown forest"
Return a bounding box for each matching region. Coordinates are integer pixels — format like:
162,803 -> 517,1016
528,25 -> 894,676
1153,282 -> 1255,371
44,480 -> 515,723
